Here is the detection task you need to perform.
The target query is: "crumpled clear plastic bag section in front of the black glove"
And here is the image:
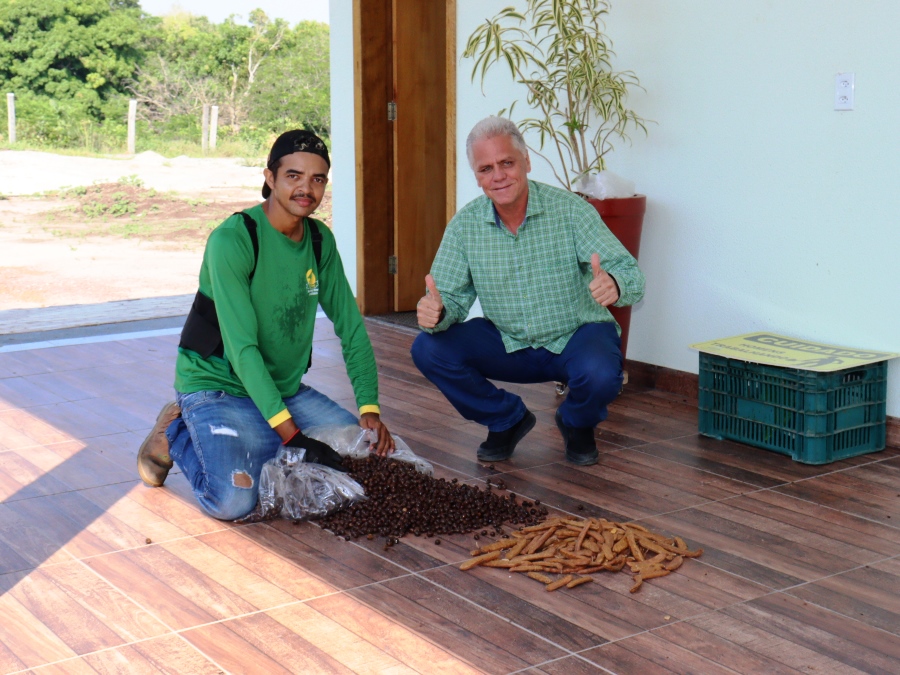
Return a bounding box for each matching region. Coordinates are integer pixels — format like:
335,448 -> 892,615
237,447 -> 366,523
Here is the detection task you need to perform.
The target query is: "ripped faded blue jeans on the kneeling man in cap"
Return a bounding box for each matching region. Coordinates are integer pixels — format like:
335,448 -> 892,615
166,384 -> 357,520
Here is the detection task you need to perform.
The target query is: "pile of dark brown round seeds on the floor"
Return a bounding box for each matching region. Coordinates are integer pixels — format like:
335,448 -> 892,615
318,455 -> 547,546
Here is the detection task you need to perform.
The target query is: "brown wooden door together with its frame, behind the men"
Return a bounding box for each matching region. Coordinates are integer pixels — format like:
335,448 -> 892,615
354,0 -> 456,315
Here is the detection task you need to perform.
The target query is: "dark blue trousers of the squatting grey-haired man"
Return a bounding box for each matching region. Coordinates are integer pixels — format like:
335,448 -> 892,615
412,318 -> 623,431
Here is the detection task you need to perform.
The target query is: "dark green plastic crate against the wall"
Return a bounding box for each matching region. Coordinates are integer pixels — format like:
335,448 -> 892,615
699,352 -> 887,464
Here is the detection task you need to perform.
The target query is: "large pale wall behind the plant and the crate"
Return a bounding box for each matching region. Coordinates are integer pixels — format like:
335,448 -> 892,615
458,0 -> 900,416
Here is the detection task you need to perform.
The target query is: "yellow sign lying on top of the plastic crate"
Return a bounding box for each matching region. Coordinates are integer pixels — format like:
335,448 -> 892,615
691,333 -> 900,373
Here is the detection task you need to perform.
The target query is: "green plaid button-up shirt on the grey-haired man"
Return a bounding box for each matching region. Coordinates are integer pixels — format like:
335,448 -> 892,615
429,180 -> 644,354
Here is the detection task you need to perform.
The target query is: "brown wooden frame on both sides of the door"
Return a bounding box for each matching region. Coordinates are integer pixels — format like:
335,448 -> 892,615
353,0 -> 456,316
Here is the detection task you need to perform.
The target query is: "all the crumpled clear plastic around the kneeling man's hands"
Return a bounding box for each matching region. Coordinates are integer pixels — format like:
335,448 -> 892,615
237,425 -> 434,523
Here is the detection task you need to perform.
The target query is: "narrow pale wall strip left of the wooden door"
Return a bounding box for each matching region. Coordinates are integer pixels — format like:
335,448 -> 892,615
328,0 -> 356,293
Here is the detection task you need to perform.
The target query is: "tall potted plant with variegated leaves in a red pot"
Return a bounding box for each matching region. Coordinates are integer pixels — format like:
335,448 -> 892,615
463,0 -> 647,357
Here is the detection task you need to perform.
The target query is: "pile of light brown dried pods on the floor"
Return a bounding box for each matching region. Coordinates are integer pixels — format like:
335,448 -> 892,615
460,518 -> 703,593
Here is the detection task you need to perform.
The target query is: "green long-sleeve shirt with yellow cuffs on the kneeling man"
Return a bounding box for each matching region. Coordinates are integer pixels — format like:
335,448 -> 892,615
175,204 -> 379,427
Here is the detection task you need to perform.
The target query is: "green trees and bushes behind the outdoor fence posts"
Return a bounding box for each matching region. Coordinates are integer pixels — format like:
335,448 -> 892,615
0,0 -> 330,158
